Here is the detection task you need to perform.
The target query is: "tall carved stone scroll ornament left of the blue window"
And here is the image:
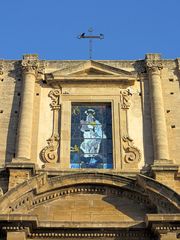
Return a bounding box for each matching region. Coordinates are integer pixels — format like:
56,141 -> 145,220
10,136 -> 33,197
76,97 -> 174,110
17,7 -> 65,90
41,89 -> 60,163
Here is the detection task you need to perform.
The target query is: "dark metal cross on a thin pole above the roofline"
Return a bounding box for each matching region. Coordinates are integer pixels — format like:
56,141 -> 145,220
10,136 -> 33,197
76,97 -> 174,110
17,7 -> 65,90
78,28 -> 104,59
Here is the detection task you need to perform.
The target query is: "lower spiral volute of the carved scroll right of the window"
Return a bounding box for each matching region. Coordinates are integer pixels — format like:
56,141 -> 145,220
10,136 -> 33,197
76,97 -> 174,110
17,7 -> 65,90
122,136 -> 141,163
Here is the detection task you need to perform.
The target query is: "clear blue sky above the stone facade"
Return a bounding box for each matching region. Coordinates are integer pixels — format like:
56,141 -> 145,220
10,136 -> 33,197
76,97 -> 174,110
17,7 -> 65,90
0,0 -> 180,60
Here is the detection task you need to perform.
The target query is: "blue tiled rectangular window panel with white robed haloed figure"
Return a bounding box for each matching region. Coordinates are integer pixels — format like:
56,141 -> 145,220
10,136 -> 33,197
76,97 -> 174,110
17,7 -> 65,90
70,103 -> 113,169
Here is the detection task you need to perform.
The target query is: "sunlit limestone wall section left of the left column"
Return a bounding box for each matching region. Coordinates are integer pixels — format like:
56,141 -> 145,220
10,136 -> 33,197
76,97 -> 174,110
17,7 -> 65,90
0,61 -> 22,168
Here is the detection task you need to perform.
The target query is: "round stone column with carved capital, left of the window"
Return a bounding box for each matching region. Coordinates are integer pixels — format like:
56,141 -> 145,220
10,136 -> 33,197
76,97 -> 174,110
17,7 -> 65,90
16,54 -> 38,161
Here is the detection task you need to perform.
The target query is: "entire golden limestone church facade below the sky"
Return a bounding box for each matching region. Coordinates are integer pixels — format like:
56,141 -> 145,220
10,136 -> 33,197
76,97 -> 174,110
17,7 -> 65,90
0,54 -> 180,240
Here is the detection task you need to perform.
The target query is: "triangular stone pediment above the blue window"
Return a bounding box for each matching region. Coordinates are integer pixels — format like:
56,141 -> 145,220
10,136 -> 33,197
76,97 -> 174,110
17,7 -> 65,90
46,60 -> 137,85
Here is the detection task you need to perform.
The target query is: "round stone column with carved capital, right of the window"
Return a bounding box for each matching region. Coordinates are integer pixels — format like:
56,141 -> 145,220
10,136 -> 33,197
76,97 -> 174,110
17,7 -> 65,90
146,54 -> 169,161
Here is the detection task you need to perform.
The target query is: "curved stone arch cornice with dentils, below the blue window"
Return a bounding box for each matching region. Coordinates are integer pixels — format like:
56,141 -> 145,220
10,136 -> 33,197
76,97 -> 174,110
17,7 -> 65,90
0,173 -> 179,214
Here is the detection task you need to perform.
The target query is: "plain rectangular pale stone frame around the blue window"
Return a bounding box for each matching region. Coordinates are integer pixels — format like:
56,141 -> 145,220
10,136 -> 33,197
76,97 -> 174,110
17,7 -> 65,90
59,95 -> 121,172
